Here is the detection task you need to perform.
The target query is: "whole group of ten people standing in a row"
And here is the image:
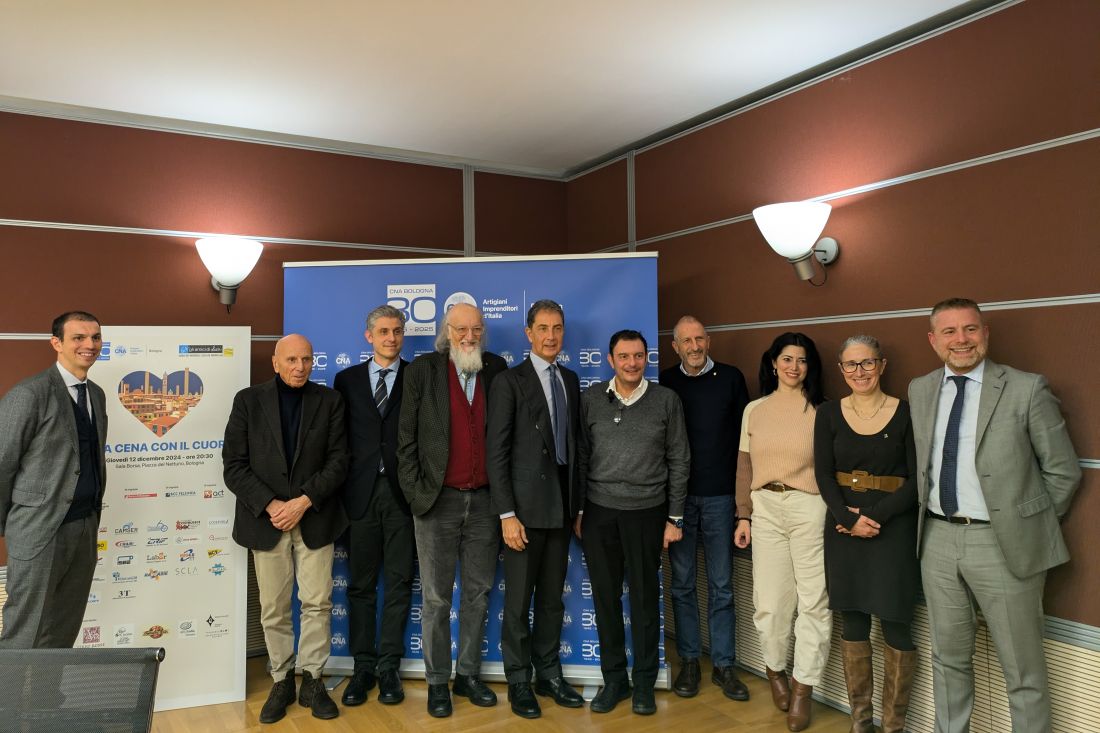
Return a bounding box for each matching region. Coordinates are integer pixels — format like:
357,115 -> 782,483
0,298 -> 1080,733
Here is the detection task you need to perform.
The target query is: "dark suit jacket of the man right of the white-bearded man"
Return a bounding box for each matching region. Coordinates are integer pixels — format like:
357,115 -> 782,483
485,359 -> 581,521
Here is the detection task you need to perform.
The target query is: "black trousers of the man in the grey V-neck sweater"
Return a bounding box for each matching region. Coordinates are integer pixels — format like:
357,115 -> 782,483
581,502 -> 667,689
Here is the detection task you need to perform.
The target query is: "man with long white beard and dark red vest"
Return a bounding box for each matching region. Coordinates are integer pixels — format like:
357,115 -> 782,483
397,303 -> 508,718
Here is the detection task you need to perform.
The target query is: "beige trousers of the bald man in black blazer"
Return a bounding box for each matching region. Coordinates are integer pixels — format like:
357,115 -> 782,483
252,527 -> 332,682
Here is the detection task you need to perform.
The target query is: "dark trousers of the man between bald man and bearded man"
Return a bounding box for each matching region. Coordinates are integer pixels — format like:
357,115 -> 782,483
348,475 -> 416,672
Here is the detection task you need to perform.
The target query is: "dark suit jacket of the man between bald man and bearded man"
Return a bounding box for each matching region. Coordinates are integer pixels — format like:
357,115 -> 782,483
332,359 -> 409,519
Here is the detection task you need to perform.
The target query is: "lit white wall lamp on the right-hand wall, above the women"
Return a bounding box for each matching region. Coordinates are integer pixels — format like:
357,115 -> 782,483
752,201 -> 840,285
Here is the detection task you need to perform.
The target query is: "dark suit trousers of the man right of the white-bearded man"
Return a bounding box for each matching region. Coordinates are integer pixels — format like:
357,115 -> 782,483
501,526 -> 571,683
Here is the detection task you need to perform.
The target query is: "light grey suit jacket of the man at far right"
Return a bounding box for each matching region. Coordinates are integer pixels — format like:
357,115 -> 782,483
909,359 -> 1081,578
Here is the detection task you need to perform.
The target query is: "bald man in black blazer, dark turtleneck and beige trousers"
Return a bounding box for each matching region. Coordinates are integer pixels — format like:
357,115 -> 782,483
222,333 -> 348,723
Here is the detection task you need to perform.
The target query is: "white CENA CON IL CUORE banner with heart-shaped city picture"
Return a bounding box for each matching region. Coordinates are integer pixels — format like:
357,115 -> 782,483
77,326 -> 251,710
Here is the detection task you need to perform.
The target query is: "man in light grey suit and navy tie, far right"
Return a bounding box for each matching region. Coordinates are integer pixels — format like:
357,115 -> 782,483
909,298 -> 1081,733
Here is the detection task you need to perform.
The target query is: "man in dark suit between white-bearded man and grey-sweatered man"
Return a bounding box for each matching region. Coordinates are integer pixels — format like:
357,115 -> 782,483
486,300 -> 584,718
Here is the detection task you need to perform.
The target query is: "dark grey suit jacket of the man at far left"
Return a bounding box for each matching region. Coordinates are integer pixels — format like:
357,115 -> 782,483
0,365 -> 107,560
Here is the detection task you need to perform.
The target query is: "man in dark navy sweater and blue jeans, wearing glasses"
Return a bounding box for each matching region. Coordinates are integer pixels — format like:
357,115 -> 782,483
660,316 -> 749,701
